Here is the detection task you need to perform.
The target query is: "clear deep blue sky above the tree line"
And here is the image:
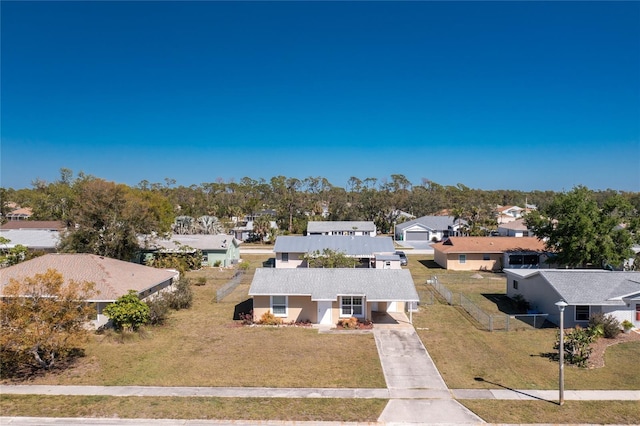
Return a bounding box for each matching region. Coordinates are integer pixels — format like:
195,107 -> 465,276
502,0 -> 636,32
0,1 -> 640,191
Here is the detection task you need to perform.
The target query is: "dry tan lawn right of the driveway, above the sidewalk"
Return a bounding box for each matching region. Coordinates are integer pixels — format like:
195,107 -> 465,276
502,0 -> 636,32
409,251 -> 640,390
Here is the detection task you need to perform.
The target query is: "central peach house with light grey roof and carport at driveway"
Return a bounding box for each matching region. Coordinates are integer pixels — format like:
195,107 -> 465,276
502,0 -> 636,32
249,268 -> 419,325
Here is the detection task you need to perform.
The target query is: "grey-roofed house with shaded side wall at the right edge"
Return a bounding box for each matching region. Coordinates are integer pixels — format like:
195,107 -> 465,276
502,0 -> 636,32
504,269 -> 640,328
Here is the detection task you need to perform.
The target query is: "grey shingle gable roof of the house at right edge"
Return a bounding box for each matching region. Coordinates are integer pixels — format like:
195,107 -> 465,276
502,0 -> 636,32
505,269 -> 640,305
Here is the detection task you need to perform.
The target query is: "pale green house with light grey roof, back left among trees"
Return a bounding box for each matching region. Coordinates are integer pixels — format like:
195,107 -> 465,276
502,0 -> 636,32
139,234 -> 240,266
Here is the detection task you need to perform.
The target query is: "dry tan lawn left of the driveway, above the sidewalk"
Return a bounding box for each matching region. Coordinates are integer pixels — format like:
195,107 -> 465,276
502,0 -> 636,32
8,255 -> 385,388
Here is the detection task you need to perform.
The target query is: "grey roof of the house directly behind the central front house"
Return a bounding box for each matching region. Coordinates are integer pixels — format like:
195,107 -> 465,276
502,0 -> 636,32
273,235 -> 395,257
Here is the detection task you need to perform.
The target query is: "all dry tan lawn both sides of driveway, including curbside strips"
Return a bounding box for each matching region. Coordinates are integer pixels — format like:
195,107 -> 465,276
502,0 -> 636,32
0,251 -> 640,424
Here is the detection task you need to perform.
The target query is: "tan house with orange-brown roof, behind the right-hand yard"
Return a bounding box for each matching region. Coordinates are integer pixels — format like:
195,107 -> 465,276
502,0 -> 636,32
432,237 -> 548,271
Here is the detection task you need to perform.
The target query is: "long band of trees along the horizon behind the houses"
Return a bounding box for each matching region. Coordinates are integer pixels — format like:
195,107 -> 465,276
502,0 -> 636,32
0,168 -> 640,266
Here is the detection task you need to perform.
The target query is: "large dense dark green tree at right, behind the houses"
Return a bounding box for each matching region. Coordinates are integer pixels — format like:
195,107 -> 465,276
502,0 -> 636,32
525,186 -> 640,268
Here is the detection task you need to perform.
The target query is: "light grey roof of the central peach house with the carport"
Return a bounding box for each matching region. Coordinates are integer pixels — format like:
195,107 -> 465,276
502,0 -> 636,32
249,268 -> 420,302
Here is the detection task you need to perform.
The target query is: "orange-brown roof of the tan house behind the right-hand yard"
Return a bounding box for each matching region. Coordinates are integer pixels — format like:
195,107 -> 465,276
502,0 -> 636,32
432,237 -> 545,253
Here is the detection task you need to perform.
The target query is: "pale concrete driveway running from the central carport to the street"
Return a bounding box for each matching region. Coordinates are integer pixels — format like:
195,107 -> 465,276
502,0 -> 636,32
373,314 -> 484,424
